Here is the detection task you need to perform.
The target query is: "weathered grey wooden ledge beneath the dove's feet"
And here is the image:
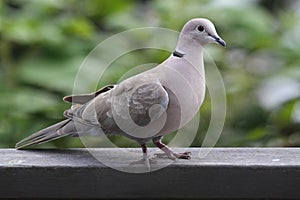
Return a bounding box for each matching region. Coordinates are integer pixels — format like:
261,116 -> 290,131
0,148 -> 300,199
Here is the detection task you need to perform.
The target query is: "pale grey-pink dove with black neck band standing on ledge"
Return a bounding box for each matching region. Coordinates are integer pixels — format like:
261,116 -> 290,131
16,18 -> 226,165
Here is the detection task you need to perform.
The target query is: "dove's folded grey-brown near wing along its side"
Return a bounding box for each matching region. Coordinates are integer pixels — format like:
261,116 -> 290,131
64,78 -> 169,138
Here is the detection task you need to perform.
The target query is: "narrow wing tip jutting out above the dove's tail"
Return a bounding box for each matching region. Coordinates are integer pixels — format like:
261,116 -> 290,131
63,85 -> 115,104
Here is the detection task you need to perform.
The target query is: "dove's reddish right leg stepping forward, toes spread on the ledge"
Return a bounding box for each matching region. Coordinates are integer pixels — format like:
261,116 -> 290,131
152,136 -> 191,160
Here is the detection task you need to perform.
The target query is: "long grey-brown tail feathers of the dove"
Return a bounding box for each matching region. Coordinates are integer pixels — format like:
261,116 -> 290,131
15,119 -> 76,149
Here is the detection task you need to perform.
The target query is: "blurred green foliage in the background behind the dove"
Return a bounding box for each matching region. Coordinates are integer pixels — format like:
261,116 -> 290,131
0,0 -> 300,147
